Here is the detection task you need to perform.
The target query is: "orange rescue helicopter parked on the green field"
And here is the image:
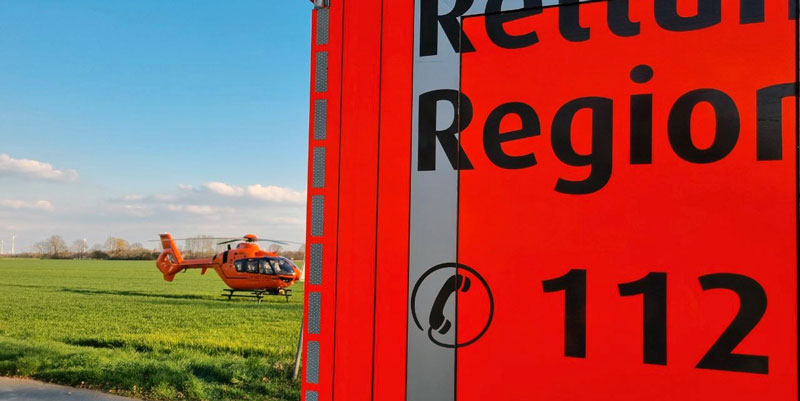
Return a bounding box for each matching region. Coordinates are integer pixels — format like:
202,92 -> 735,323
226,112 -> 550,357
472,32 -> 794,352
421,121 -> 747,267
156,233 -> 301,303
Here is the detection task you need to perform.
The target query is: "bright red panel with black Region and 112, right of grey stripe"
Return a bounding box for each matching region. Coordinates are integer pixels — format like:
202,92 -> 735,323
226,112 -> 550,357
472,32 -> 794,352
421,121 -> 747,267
454,0 -> 798,401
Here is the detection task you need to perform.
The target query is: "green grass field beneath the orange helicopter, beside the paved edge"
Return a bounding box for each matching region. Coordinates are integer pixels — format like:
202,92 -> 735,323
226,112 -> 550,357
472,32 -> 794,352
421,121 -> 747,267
0,259 -> 303,400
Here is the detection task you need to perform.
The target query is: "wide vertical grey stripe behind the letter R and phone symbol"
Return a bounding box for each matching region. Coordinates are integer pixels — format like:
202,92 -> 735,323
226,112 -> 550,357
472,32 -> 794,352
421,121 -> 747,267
406,0 -> 583,401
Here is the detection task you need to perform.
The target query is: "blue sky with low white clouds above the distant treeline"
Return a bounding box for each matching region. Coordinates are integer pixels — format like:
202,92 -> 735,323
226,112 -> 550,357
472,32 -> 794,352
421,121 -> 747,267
0,0 -> 312,251
